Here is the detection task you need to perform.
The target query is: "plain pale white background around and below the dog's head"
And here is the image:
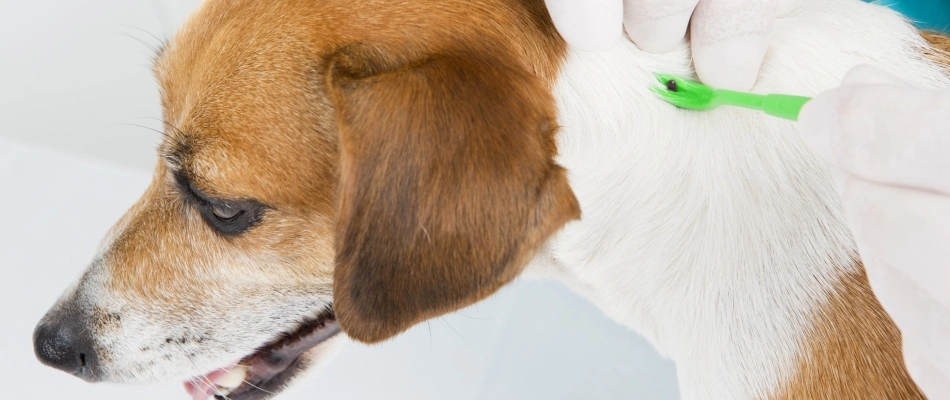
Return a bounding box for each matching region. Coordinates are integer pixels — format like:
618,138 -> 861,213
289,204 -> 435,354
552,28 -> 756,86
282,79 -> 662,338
0,0 -> 677,400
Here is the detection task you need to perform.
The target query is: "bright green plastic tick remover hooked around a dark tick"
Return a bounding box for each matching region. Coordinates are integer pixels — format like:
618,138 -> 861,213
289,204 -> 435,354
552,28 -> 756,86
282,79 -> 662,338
650,74 -> 811,121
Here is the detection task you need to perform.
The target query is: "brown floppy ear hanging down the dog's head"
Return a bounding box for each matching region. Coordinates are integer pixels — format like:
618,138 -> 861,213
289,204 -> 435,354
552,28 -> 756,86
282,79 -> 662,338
327,48 -> 580,343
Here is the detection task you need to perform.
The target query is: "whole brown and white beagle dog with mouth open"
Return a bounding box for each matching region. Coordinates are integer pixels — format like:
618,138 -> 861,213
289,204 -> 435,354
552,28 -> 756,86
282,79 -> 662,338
34,0 -> 950,400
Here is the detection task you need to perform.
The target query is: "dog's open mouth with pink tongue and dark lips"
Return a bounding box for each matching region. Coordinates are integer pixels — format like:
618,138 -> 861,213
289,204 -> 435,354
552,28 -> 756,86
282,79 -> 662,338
185,309 -> 340,400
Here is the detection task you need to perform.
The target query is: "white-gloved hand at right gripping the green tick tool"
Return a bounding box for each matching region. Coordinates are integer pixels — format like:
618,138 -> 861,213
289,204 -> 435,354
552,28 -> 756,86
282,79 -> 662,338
799,66 -> 950,399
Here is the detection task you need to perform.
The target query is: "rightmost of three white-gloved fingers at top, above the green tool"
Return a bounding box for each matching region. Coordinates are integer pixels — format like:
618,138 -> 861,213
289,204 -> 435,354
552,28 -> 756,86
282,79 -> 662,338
690,0 -> 778,91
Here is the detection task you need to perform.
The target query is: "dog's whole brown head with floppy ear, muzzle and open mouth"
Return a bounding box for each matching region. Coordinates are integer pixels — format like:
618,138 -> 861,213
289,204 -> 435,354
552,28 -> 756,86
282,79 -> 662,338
34,0 -> 579,399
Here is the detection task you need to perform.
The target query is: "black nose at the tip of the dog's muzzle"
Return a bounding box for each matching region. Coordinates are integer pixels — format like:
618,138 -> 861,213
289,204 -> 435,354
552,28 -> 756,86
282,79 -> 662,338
33,316 -> 97,381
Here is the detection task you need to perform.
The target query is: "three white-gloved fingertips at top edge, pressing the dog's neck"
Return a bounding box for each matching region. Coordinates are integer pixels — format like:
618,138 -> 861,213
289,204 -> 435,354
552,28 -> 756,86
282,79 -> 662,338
545,0 -> 795,91
